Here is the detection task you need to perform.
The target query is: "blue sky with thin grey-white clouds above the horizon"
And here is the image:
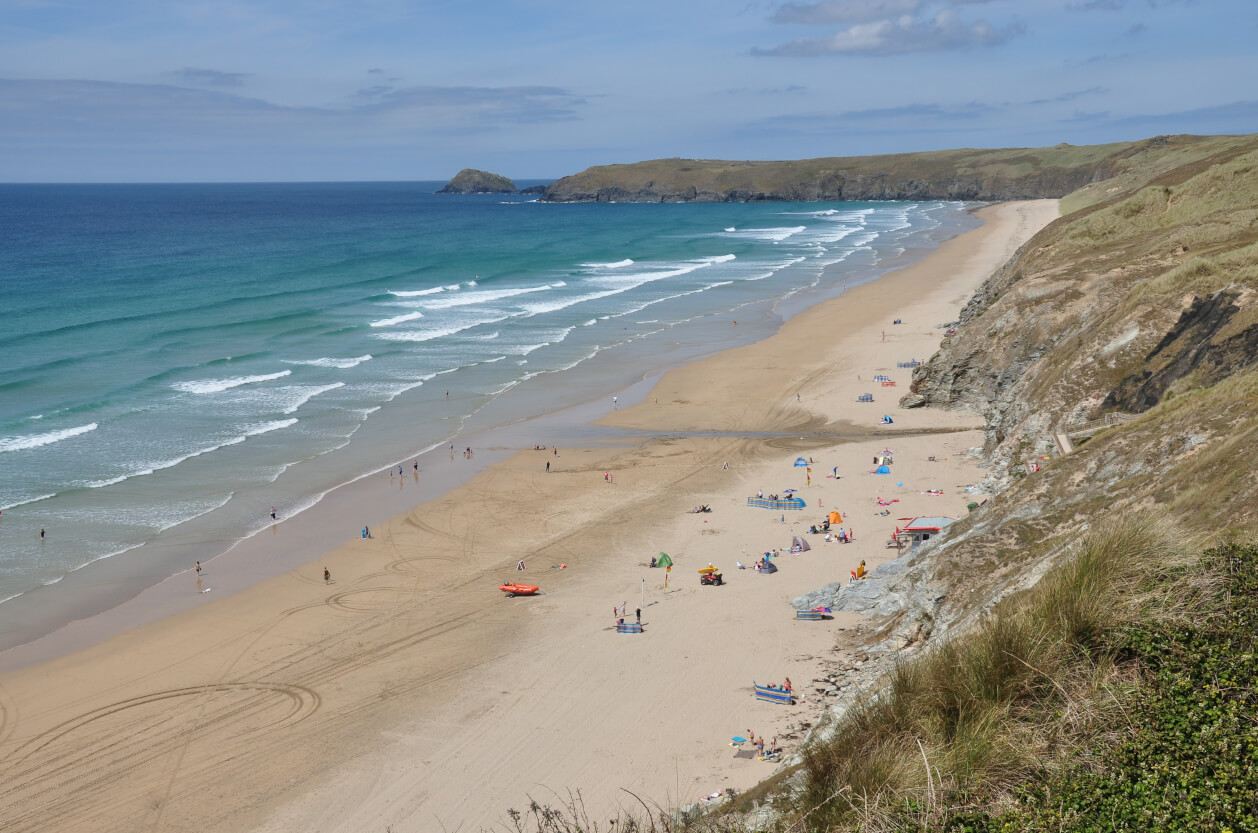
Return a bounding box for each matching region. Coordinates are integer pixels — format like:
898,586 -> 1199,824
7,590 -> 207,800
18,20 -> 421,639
0,0 -> 1258,182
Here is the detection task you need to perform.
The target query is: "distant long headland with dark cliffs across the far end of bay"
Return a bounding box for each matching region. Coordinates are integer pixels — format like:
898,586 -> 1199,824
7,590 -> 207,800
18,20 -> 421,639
542,136 -> 1215,203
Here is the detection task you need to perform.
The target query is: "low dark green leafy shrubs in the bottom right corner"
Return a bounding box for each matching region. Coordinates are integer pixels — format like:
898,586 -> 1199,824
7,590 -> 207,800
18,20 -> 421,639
933,546 -> 1258,833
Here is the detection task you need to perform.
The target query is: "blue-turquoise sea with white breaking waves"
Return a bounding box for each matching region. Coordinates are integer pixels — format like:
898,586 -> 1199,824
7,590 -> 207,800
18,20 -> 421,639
0,182 -> 976,644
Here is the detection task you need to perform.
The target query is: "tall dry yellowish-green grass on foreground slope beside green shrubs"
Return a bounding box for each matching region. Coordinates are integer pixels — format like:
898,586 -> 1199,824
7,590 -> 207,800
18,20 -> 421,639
794,516 -> 1209,830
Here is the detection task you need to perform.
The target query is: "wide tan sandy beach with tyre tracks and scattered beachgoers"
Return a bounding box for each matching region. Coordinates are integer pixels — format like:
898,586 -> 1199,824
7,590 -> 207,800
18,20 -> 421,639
0,200 -> 1057,833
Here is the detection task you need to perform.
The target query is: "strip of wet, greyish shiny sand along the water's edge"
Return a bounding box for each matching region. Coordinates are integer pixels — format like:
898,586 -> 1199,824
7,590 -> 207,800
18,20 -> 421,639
0,198 -> 981,672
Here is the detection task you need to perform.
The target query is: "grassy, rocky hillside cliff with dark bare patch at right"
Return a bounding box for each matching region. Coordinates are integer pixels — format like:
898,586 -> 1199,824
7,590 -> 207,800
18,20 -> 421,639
902,137 -> 1258,503
